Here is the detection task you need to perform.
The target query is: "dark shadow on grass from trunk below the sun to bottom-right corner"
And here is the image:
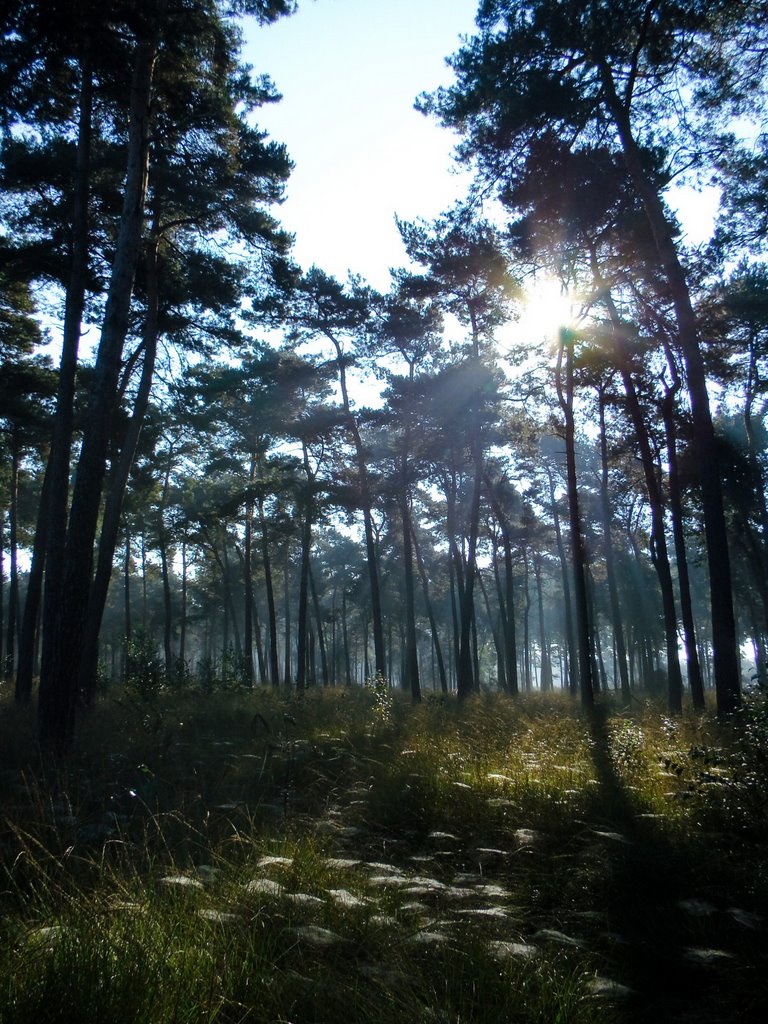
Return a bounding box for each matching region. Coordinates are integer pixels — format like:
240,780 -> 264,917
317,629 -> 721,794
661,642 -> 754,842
581,702 -> 768,1024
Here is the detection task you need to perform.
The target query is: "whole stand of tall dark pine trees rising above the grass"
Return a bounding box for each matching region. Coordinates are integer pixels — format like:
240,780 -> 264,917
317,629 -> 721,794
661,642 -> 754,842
0,0 -> 768,756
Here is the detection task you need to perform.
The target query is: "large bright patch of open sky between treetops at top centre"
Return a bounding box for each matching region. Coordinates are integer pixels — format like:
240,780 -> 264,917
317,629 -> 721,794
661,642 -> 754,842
244,0 -> 477,290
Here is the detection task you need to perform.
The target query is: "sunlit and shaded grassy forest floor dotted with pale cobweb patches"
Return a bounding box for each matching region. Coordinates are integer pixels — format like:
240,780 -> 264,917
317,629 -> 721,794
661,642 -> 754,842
0,688 -> 768,1024
